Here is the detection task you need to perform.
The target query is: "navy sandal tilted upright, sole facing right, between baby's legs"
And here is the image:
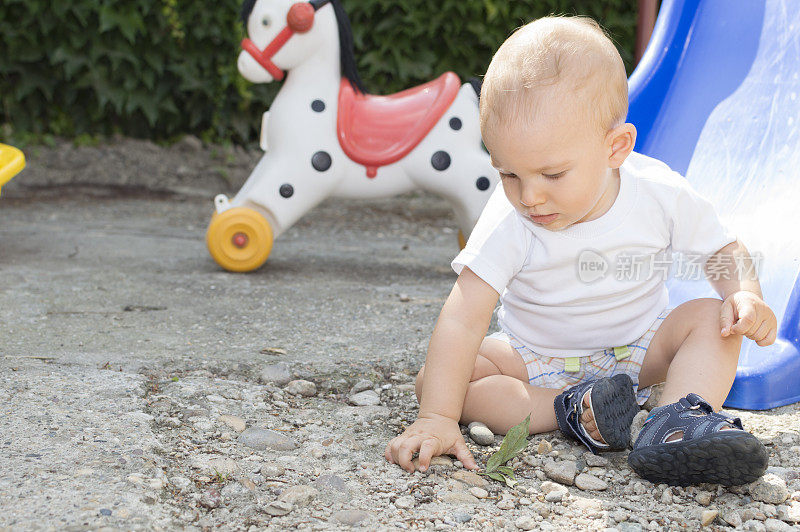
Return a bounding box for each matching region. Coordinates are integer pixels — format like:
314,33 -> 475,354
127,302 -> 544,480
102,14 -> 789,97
553,374 -> 639,454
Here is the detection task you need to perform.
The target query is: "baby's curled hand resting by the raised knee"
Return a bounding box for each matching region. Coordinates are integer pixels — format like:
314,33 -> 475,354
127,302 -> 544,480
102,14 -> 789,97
719,290 -> 778,347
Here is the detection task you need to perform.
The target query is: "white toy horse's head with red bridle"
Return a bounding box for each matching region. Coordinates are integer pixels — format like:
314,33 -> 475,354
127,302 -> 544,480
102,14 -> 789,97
237,0 -> 336,83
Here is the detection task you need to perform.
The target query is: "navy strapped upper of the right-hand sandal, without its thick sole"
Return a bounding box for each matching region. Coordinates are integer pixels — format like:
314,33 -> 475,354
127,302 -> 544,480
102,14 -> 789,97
633,393 -> 744,449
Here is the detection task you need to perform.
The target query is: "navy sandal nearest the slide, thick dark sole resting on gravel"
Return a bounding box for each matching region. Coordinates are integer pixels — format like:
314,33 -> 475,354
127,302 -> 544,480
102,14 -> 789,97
628,393 -> 768,486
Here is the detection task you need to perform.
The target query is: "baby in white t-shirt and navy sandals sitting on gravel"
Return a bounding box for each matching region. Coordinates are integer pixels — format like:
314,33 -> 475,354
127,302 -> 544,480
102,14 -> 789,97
385,17 -> 777,485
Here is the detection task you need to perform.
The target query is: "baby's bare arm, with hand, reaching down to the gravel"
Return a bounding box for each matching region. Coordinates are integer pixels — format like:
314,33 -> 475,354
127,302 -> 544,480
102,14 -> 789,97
384,268 -> 499,472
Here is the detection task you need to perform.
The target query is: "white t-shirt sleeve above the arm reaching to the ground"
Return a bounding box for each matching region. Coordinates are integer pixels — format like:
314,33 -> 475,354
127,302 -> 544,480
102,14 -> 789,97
451,185 -> 532,295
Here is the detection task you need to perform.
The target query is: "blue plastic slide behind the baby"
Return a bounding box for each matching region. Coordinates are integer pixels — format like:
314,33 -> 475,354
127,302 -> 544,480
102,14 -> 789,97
628,0 -> 800,410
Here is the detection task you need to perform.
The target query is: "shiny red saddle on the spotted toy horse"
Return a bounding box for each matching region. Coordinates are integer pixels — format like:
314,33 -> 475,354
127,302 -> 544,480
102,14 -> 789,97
336,72 -> 461,177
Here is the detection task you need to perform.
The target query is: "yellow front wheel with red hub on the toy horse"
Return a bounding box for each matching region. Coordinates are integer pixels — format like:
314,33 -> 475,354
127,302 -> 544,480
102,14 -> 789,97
206,207 -> 273,272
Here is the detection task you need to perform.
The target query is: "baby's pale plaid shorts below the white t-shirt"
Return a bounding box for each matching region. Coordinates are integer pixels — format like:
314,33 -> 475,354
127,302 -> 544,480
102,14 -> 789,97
489,308 -> 672,405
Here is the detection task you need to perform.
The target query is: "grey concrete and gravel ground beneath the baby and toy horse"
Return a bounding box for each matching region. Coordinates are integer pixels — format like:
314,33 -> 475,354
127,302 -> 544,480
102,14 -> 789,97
0,138 -> 800,531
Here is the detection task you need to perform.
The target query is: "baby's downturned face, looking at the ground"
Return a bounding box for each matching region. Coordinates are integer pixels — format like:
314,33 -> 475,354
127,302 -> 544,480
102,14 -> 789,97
484,108 -> 618,231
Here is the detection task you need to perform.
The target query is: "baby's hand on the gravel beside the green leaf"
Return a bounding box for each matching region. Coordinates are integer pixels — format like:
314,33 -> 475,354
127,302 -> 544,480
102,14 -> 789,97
384,414 -> 478,473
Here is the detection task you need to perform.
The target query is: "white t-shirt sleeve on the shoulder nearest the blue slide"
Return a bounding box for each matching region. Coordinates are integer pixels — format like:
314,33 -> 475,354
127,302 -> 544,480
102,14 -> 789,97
670,177 -> 736,256
